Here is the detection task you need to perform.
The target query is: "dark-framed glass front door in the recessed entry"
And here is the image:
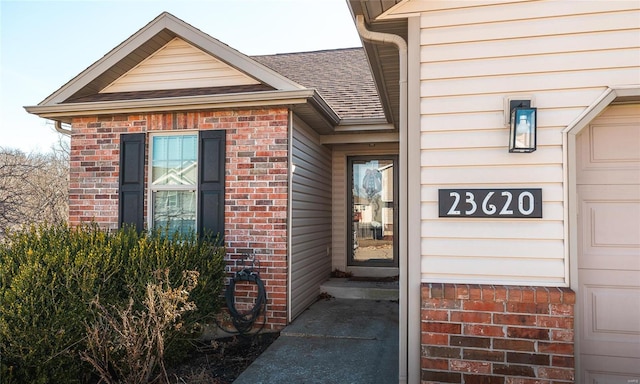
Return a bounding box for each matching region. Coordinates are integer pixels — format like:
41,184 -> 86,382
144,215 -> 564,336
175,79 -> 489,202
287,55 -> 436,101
347,156 -> 398,267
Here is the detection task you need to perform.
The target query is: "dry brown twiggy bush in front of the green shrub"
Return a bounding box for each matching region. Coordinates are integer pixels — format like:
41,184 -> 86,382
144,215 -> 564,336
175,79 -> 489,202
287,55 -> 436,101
80,269 -> 198,384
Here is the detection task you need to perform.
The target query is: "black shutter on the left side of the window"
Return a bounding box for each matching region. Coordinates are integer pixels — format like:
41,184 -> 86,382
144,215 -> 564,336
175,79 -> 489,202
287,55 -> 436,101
118,133 -> 145,231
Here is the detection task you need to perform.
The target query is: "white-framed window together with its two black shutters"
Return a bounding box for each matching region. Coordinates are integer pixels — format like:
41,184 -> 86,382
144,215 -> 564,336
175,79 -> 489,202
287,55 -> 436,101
119,131 -> 225,237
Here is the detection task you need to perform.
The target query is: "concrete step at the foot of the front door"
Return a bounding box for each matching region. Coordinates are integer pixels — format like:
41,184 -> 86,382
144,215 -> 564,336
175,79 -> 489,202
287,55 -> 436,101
320,278 -> 399,300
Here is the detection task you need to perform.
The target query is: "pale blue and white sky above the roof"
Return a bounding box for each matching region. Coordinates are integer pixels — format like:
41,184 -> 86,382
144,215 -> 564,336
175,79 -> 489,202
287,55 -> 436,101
0,0 -> 362,153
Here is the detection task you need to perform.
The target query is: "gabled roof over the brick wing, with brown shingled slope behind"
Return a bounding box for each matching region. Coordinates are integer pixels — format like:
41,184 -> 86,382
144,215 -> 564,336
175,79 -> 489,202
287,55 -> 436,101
25,12 -> 384,133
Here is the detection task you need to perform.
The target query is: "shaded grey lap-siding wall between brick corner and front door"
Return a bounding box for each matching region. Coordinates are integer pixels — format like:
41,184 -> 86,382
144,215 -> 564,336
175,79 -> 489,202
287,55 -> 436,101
290,119 -> 331,320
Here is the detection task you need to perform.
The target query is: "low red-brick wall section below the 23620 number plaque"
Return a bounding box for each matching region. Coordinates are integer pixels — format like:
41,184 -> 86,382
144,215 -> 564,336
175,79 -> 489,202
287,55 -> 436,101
421,283 -> 575,384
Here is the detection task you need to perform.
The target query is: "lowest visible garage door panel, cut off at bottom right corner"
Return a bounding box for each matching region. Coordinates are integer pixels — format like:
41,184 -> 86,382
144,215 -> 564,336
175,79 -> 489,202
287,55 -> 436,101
582,355 -> 639,384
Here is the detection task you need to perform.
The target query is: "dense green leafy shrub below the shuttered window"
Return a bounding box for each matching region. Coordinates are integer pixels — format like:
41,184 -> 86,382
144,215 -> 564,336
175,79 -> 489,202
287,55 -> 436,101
0,225 -> 224,384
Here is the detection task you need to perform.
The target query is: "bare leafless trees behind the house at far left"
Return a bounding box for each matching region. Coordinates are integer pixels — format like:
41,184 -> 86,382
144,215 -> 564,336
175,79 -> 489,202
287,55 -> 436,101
0,140 -> 69,238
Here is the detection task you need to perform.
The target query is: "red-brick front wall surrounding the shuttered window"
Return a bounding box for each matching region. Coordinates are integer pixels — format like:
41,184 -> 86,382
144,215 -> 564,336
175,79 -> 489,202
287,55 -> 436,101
69,108 -> 288,329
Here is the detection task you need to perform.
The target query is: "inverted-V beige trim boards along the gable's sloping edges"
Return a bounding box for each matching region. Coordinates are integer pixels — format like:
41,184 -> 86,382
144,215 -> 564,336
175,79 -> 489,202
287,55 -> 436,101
38,12 -> 304,106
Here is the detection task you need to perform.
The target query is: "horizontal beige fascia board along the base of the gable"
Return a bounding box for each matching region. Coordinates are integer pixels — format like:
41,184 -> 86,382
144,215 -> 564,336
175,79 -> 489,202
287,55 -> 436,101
24,89 -> 321,120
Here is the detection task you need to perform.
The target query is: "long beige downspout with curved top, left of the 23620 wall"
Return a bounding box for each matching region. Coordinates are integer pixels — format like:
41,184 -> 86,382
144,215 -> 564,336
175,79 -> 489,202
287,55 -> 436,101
356,15 -> 410,383
